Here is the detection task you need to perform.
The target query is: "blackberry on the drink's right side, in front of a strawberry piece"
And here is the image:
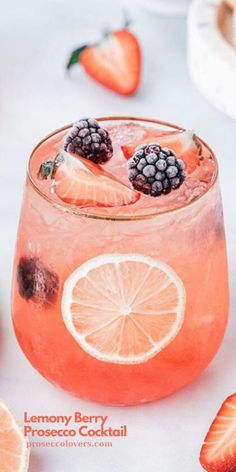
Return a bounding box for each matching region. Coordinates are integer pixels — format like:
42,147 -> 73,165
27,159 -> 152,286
128,144 -> 186,197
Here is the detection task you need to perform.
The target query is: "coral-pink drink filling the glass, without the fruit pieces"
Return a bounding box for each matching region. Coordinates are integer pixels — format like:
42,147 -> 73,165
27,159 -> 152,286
13,121 -> 228,405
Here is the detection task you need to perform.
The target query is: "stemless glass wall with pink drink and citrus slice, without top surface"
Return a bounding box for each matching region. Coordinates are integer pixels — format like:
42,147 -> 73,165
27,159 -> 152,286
12,117 -> 228,405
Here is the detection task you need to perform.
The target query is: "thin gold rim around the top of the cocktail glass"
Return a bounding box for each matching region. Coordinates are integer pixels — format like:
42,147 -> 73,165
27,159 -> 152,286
27,116 -> 219,221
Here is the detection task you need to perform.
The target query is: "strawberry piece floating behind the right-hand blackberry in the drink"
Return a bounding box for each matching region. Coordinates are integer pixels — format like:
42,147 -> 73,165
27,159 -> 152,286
121,131 -> 201,174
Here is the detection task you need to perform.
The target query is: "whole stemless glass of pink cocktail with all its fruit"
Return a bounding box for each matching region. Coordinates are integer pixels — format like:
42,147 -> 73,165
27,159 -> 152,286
13,117 -> 228,405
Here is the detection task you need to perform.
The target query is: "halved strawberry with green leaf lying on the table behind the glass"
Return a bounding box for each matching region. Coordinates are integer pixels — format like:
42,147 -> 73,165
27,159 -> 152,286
67,28 -> 141,95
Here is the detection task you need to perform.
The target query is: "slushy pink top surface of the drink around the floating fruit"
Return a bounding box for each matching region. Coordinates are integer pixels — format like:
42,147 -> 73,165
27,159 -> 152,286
30,121 -> 217,217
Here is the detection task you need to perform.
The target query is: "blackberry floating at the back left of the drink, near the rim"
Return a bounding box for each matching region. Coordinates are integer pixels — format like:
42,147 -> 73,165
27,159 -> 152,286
64,118 -> 113,164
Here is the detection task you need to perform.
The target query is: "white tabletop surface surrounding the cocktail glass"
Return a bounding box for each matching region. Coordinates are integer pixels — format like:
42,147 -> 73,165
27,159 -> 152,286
0,0 -> 236,472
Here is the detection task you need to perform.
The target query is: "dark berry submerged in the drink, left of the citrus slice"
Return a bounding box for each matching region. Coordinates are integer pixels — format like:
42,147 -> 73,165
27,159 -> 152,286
17,257 -> 59,304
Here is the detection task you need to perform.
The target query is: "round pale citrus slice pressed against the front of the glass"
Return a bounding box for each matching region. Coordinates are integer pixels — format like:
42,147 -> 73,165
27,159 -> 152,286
62,254 -> 186,364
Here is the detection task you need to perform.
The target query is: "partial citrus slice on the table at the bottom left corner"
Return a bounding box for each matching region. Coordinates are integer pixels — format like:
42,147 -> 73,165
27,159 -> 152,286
0,400 -> 30,472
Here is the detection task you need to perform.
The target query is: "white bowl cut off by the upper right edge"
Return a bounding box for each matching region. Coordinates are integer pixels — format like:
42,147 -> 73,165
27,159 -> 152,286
188,0 -> 236,119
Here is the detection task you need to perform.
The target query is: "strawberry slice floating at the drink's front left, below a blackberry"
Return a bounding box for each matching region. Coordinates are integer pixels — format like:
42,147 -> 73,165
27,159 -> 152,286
38,151 -> 140,208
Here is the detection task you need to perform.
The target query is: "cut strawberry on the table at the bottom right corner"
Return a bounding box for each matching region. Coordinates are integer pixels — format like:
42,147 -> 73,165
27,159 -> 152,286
200,394 -> 236,472
